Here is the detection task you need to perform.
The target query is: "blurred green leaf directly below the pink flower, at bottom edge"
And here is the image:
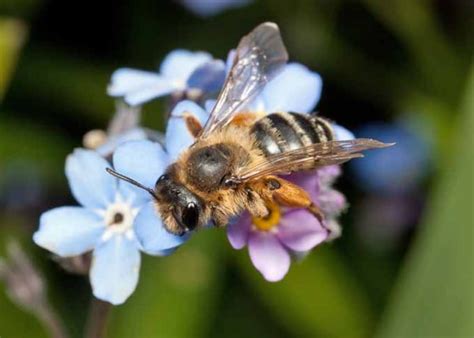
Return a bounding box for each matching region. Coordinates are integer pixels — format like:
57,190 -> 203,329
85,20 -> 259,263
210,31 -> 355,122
239,247 -> 373,338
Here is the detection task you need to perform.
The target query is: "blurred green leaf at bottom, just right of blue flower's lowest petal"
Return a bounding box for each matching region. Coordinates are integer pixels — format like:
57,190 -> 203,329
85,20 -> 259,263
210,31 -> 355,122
108,231 -> 224,338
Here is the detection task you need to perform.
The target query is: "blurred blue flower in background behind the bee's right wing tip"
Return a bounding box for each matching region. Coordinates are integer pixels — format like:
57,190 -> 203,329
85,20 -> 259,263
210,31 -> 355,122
350,122 -> 431,194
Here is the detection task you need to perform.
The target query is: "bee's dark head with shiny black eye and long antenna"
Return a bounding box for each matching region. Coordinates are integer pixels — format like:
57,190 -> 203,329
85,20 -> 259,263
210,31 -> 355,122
106,168 -> 205,235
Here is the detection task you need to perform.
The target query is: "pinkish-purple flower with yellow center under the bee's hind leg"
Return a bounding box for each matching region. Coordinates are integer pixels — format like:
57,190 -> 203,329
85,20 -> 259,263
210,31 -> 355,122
227,166 -> 346,282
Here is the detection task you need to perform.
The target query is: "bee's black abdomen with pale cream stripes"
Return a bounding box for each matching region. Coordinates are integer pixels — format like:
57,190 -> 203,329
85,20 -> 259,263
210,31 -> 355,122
251,113 -> 334,156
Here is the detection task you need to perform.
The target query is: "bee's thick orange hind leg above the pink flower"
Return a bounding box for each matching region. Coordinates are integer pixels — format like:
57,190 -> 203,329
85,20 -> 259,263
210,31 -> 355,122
258,176 -> 324,224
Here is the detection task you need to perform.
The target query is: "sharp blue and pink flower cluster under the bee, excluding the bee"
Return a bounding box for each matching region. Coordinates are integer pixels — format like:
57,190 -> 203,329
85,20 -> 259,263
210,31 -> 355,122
33,46 -> 353,304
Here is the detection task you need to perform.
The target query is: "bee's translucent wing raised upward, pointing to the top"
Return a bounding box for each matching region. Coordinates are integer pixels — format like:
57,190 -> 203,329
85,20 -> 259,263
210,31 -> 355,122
199,22 -> 288,138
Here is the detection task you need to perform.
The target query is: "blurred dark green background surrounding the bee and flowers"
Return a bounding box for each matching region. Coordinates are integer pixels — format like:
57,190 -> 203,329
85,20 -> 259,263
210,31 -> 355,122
0,0 -> 474,338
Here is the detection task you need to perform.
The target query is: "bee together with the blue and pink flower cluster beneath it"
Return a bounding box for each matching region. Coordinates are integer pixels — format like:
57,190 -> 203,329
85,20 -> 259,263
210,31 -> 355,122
34,23 -> 387,304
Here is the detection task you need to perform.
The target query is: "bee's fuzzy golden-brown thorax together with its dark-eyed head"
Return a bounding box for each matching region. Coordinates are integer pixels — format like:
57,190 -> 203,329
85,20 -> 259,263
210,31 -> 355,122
155,126 -> 260,234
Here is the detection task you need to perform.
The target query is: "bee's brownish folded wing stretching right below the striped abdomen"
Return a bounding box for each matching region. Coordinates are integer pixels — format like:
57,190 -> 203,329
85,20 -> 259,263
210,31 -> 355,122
232,138 -> 393,183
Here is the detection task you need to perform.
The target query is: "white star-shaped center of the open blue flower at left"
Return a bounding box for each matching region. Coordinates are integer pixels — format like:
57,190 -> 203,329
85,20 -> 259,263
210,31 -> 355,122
100,195 -> 138,241
